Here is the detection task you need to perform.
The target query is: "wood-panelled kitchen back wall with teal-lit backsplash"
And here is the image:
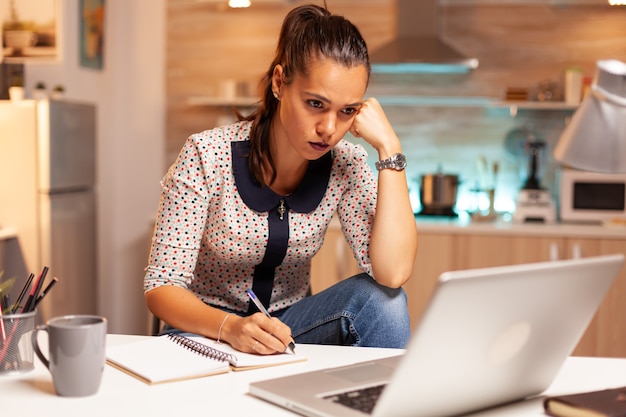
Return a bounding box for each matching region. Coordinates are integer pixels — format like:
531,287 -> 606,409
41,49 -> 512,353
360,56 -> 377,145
166,0 -> 626,214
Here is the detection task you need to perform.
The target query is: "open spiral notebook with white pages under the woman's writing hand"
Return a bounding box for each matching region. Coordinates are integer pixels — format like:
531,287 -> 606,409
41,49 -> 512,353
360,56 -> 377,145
107,333 -> 306,384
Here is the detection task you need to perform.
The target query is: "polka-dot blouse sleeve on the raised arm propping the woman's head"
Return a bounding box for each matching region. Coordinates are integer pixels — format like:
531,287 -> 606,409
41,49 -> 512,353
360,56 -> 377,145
337,142 -> 378,275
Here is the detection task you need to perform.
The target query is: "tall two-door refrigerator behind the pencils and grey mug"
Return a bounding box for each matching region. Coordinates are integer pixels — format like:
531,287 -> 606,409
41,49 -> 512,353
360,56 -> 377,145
0,100 -> 98,321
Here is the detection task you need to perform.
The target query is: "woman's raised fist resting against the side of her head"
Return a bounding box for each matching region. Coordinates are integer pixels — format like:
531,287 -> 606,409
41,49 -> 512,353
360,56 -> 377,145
350,97 -> 400,157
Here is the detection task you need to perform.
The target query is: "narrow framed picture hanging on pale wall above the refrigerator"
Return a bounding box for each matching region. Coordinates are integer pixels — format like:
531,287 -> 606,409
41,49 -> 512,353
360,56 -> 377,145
79,0 -> 105,69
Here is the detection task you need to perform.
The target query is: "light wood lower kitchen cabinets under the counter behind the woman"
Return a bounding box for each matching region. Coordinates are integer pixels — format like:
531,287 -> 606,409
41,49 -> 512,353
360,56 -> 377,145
312,225 -> 626,357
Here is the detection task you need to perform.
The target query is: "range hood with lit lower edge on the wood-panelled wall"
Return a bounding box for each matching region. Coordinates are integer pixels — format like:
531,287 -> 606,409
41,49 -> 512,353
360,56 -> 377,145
370,0 -> 478,74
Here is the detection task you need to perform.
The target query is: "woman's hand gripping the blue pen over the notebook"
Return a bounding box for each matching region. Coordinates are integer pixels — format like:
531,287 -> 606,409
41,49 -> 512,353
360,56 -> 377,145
221,313 -> 293,355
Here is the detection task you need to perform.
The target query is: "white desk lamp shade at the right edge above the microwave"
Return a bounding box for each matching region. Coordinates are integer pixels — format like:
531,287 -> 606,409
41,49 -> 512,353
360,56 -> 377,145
554,60 -> 626,173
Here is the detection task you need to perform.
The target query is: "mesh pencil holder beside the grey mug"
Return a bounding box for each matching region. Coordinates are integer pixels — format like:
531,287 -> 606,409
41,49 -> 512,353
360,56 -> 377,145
0,310 -> 36,375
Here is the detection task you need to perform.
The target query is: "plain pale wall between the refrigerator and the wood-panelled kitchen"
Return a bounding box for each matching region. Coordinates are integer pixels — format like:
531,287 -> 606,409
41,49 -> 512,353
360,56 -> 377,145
25,0 -> 166,333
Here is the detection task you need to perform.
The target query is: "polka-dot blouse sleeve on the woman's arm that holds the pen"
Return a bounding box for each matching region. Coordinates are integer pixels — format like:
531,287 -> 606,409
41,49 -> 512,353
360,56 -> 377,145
144,135 -> 215,292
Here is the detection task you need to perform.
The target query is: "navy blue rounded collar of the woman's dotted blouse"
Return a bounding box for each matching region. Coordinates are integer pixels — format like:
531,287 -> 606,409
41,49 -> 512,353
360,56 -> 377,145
231,141 -> 333,213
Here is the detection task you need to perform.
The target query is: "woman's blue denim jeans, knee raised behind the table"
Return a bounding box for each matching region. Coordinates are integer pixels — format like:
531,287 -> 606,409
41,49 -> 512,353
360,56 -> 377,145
273,273 -> 411,348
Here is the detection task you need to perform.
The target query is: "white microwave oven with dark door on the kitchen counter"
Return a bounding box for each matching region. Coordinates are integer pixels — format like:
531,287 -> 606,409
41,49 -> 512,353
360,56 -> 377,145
559,168 -> 626,223
